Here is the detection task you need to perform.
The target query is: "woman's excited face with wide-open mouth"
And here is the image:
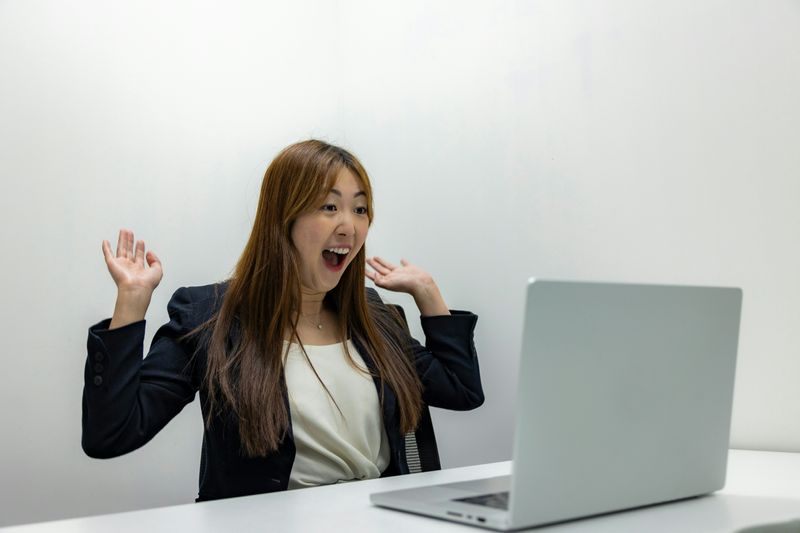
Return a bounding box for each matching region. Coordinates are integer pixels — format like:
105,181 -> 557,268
292,168 -> 369,293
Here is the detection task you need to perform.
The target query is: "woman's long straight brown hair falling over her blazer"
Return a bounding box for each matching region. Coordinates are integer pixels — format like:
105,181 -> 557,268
201,140 -> 422,457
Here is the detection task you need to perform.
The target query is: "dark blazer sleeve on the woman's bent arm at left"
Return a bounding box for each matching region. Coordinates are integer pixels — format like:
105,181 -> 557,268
81,288 -> 203,458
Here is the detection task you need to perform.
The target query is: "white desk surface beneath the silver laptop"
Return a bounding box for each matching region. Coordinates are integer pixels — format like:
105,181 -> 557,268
2,450 -> 800,533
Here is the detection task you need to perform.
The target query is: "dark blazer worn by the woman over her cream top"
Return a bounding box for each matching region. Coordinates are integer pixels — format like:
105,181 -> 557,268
81,283 -> 483,501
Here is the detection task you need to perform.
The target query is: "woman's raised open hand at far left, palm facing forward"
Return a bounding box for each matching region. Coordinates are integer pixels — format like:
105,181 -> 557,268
103,229 -> 164,297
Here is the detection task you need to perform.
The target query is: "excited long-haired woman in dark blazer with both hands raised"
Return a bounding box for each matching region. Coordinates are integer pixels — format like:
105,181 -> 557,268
82,140 -> 483,501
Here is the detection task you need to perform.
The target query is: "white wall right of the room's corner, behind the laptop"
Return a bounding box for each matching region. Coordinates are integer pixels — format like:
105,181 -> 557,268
340,0 -> 800,474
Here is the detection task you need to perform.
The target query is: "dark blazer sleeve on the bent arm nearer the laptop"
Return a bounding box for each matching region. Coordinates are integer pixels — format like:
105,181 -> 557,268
411,310 -> 484,411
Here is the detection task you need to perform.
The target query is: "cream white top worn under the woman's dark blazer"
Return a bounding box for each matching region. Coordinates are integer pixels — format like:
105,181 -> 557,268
284,340 -> 389,489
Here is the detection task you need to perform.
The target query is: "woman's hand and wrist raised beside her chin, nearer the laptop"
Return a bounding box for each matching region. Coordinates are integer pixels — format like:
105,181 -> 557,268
365,257 -> 450,316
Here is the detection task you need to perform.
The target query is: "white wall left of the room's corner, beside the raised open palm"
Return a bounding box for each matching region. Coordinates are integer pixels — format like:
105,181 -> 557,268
0,0 -> 338,525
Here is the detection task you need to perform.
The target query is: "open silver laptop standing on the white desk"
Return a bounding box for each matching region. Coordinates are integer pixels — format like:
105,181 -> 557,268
370,279 -> 742,530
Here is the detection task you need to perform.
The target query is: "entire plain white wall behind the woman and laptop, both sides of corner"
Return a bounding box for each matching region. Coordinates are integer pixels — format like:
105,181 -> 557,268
0,0 -> 800,525
